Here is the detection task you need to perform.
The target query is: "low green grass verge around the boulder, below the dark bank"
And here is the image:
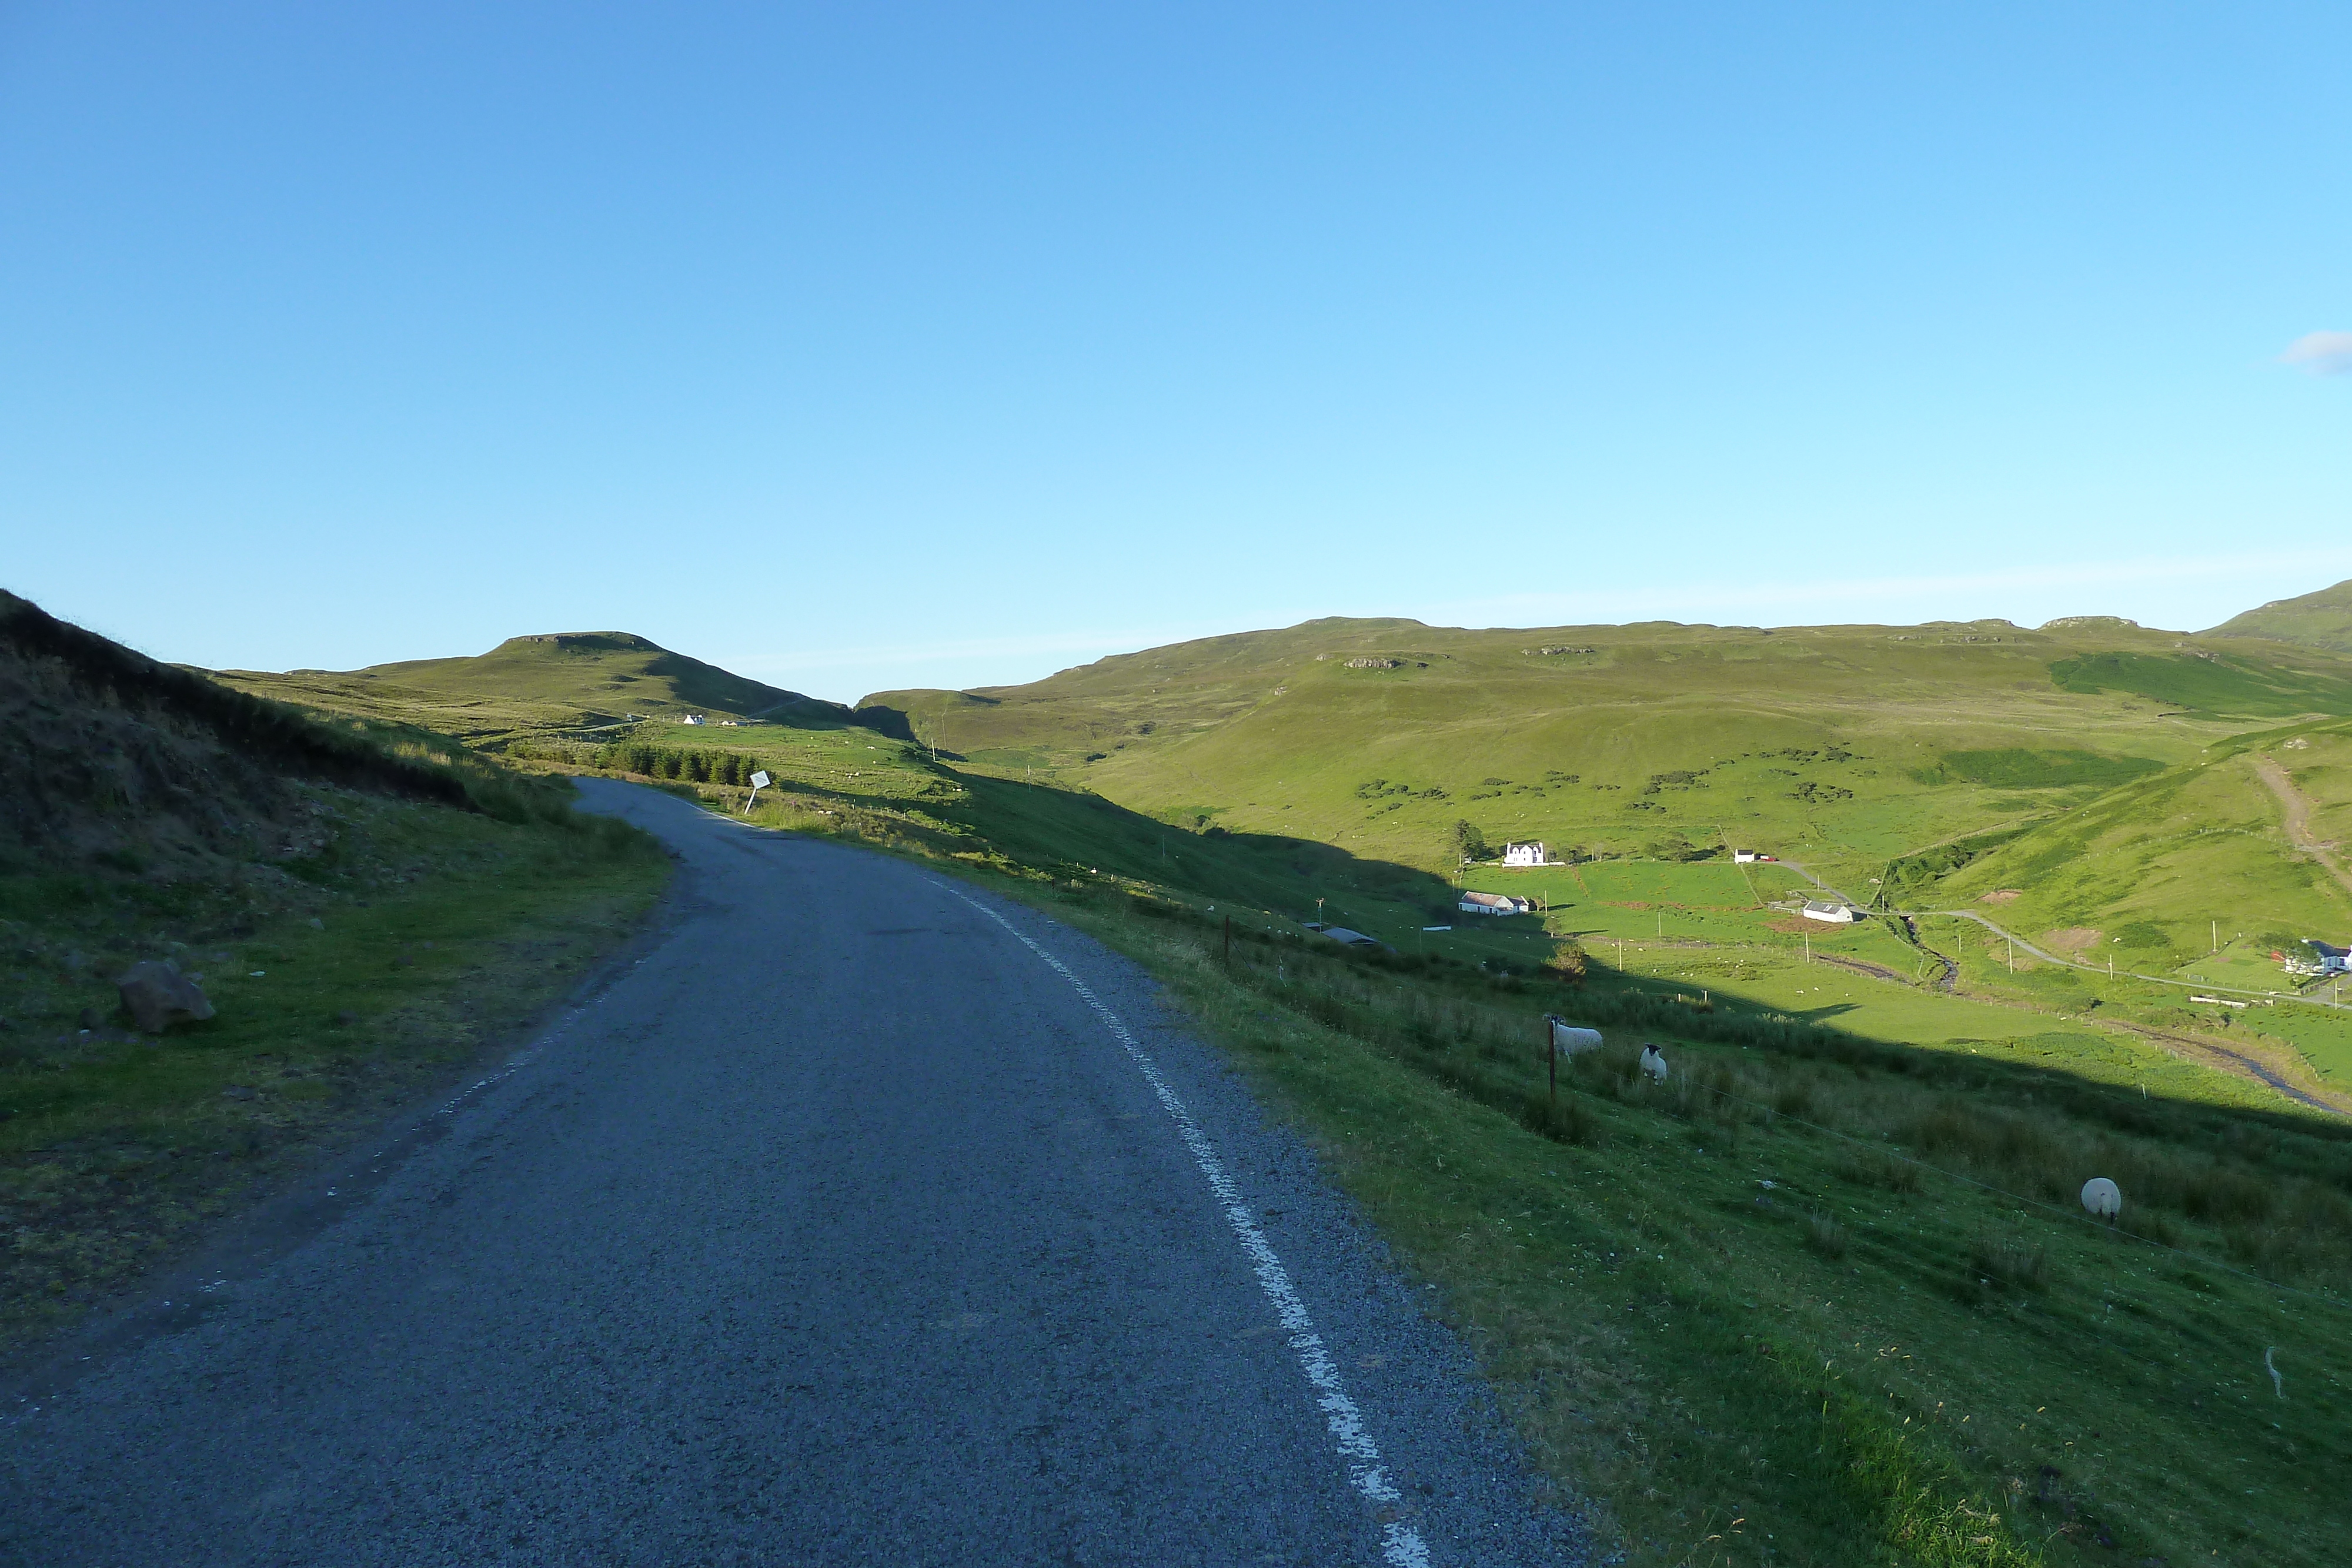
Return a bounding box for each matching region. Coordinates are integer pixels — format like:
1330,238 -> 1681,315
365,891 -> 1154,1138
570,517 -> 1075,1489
0,781 -> 668,1354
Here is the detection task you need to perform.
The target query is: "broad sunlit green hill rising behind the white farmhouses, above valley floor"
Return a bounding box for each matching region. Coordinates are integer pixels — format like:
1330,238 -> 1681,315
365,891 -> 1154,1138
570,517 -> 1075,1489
861,621 -> 2352,895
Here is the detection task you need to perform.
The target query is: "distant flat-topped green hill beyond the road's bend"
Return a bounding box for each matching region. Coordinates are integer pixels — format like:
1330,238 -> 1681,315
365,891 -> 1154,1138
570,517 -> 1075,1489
219,633 -> 849,743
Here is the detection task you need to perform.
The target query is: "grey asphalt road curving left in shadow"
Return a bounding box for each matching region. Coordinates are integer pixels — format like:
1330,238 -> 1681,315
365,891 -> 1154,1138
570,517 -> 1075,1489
0,783 -> 1588,1568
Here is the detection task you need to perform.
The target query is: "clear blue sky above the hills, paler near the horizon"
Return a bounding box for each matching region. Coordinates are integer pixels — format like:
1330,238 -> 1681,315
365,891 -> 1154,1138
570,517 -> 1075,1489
0,2 -> 2352,698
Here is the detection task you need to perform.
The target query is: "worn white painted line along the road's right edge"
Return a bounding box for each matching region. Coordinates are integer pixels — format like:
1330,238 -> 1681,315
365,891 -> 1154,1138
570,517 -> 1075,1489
938,881 -> 1430,1568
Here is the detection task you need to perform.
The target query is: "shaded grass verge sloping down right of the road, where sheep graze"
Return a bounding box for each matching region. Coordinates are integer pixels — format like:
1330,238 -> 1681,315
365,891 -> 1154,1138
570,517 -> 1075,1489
1023,886 -> 2352,1568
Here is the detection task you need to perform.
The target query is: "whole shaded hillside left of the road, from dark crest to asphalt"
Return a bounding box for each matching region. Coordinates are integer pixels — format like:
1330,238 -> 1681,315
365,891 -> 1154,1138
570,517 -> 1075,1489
0,595 -> 668,1359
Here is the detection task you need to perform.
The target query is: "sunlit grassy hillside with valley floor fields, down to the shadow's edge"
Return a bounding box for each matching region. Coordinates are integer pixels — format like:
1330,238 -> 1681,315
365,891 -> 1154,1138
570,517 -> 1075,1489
868,618 -> 2352,1098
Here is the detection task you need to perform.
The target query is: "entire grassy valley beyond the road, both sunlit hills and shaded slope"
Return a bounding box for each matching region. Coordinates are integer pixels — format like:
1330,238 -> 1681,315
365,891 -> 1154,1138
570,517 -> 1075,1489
32,592 -> 2352,1568
